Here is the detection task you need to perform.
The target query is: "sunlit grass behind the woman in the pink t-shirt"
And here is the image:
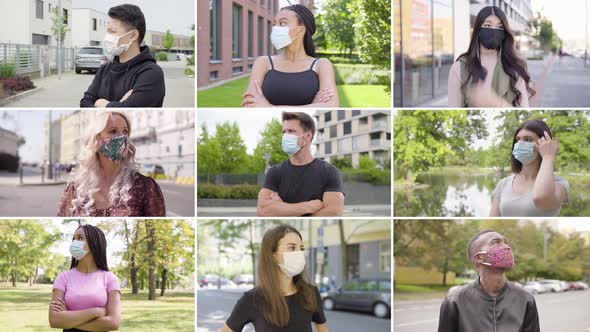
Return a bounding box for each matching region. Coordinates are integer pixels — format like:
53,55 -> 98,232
0,284 -> 195,332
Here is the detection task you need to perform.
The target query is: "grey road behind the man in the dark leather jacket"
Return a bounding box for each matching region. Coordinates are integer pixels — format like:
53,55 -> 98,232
393,290 -> 590,332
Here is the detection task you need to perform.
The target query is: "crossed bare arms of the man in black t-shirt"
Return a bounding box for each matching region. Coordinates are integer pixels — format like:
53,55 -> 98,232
256,188 -> 344,217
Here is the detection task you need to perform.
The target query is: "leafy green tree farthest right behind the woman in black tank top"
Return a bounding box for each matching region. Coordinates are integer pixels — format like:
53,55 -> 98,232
349,0 -> 391,92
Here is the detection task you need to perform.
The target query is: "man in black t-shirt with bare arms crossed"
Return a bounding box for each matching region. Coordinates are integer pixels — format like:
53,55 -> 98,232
256,112 -> 344,217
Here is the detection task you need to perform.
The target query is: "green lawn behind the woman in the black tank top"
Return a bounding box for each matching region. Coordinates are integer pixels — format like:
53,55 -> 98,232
197,77 -> 391,108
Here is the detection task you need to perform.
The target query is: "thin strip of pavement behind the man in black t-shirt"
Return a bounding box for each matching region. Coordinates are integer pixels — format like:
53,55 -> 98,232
197,203 -> 391,218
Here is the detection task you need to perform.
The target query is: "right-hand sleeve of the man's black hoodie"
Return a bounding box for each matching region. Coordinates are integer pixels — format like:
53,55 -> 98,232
107,65 -> 166,107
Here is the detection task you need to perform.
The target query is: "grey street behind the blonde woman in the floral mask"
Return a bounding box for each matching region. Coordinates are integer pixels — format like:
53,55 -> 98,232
0,169 -> 195,217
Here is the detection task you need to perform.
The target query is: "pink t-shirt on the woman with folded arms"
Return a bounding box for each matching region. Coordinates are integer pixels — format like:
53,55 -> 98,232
53,268 -> 120,310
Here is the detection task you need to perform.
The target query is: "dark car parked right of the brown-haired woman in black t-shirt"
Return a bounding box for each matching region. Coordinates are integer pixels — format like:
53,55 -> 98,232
323,279 -> 391,318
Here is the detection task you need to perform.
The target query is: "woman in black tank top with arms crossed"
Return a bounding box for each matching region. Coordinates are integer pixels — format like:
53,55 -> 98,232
242,4 -> 339,107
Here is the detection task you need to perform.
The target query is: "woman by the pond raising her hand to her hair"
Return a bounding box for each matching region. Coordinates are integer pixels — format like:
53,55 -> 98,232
490,120 -> 569,217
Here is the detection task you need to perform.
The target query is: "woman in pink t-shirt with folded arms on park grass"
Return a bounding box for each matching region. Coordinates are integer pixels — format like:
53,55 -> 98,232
49,225 -> 121,332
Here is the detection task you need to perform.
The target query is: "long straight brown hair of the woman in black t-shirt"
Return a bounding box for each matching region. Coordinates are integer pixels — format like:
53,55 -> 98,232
256,225 -> 317,327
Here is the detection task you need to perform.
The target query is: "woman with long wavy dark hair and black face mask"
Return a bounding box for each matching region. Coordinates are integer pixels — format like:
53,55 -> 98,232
448,6 -> 535,107
